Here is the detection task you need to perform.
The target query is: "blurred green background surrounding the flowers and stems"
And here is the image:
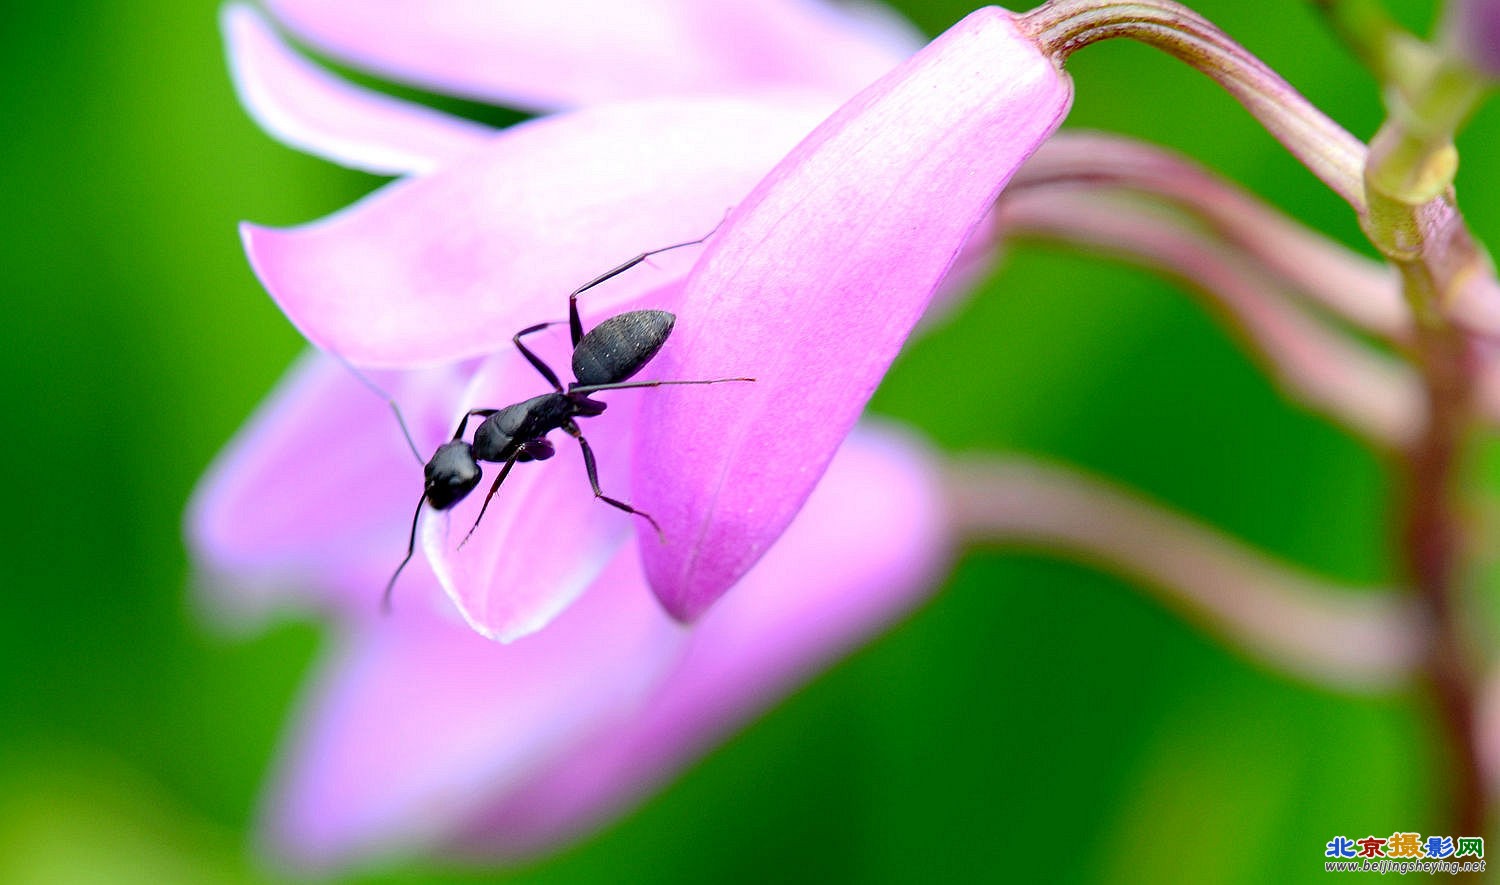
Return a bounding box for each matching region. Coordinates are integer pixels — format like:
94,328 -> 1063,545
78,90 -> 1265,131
0,0 -> 1500,885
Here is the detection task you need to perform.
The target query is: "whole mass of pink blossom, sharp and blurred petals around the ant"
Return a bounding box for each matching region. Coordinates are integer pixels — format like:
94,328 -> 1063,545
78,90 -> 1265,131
189,0 -> 1071,866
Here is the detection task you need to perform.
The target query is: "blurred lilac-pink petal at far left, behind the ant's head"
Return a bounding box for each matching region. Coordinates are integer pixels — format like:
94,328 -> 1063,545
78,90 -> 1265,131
186,354 -> 464,615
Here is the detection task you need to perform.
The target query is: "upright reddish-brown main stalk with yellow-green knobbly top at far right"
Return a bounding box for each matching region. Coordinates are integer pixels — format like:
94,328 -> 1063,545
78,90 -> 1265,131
1361,0 -> 1494,833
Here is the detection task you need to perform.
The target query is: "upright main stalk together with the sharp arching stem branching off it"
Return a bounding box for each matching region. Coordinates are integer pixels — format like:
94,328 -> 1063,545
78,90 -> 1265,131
1023,0 -> 1500,833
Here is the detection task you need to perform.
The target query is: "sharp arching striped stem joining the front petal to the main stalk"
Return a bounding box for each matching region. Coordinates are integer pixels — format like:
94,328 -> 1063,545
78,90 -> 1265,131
1020,0 -> 1365,215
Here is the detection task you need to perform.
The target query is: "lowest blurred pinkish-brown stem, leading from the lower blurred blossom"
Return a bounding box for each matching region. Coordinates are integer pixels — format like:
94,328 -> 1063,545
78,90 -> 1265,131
944,456 -> 1428,693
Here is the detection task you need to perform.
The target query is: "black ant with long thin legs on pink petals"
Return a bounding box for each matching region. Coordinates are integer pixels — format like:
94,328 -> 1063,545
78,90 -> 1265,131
367,227 -> 755,612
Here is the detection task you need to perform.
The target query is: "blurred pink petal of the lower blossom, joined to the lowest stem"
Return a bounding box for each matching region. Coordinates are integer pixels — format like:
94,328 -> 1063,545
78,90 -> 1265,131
447,426 -> 947,857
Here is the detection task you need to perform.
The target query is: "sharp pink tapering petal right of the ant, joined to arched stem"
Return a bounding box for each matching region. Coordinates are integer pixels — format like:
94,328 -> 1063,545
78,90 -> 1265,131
636,8 -> 1073,620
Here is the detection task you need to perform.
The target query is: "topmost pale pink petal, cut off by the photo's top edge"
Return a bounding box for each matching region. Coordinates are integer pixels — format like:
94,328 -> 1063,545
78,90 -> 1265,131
267,0 -> 917,110
